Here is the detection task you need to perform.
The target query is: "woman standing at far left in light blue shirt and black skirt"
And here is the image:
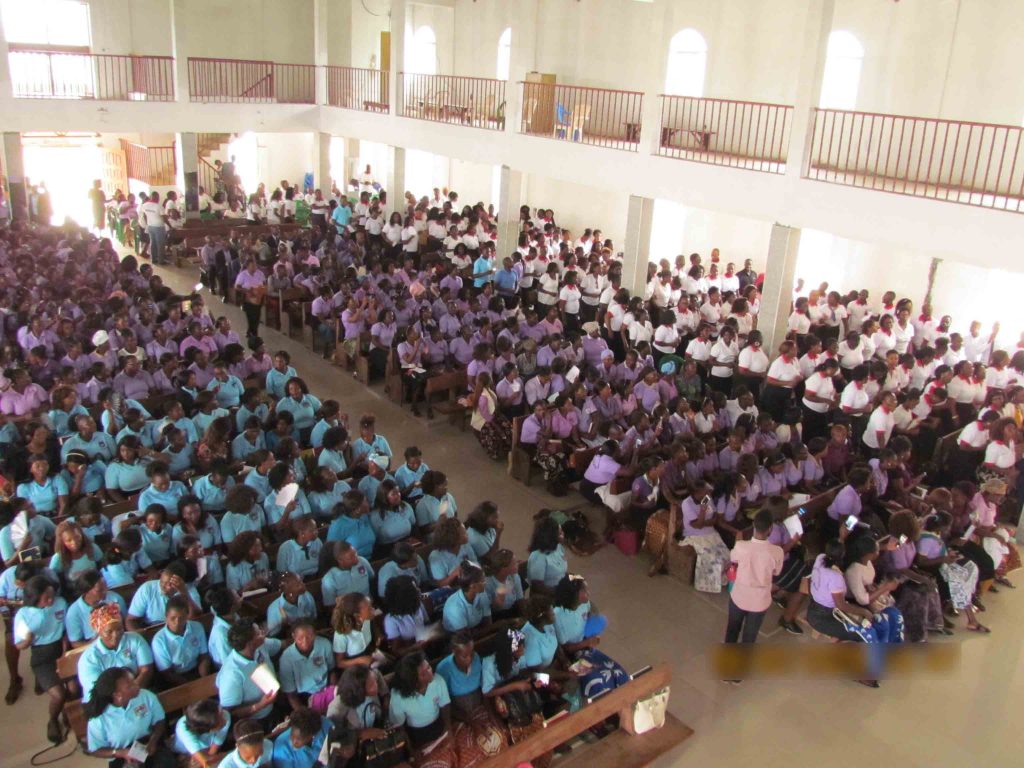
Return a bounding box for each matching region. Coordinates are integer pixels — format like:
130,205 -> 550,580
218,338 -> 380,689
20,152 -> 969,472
14,575 -> 68,743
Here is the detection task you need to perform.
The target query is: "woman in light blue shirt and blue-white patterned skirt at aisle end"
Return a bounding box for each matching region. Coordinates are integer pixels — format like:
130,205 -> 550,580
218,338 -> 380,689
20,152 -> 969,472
555,574 -> 630,697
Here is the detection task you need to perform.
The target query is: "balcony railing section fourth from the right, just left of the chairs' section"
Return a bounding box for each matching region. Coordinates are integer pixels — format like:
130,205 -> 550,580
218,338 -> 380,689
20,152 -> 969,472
398,72 -> 506,131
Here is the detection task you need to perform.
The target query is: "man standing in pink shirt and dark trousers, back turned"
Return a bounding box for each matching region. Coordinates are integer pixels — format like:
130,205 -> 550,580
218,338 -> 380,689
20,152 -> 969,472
725,509 -> 785,643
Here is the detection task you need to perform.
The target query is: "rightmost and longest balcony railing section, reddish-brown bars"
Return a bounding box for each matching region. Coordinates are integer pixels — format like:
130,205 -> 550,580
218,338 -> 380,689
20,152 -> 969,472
806,110 -> 1024,213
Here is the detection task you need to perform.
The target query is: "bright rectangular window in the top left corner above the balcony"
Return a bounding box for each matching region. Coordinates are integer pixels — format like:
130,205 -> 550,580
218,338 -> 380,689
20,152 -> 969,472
0,0 -> 91,48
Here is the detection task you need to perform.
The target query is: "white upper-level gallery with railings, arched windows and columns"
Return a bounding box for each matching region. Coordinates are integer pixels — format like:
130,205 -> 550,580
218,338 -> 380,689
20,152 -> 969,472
0,0 -> 1024,267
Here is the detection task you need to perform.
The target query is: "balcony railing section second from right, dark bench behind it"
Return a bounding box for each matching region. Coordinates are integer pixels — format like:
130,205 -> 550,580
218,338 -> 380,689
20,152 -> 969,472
657,94 -> 793,173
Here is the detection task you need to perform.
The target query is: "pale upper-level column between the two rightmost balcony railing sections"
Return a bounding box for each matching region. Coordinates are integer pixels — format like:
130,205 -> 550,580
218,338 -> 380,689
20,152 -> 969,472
785,0 -> 836,177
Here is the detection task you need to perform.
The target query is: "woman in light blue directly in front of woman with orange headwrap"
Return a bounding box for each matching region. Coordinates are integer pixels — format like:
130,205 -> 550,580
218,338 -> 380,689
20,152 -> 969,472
84,667 -> 175,768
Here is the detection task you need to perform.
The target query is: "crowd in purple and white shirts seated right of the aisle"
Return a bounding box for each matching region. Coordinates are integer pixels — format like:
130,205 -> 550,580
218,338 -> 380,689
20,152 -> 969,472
214,183 -> 1024,651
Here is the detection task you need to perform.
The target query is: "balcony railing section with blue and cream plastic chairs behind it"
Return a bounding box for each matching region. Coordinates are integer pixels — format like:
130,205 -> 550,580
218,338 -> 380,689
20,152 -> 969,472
519,83 -> 643,152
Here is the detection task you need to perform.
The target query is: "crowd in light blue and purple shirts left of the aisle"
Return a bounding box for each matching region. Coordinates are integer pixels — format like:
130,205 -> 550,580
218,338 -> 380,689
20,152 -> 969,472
0,219 -> 629,768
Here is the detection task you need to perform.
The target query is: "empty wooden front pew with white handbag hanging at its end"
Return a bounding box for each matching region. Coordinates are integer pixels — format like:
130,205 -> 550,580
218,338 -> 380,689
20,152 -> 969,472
479,664 -> 693,768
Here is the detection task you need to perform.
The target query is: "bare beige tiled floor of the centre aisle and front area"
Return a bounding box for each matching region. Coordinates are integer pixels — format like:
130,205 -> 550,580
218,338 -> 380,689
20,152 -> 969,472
0,260 -> 1024,768
